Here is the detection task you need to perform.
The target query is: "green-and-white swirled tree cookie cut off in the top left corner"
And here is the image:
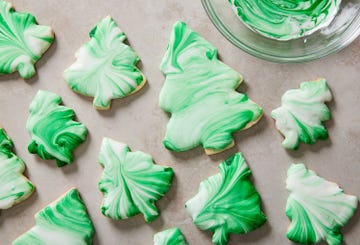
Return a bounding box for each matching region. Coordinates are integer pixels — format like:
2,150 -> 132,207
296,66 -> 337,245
0,0 -> 54,79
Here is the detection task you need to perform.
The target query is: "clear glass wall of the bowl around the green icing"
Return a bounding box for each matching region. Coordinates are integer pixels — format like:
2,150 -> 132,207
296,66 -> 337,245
202,0 -> 360,63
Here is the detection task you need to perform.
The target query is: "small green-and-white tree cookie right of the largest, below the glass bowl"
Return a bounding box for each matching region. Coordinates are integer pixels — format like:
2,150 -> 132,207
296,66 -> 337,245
271,78 -> 332,149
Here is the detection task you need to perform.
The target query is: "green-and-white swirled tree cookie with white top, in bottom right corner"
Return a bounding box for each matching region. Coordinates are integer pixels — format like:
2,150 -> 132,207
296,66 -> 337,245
286,164 -> 358,245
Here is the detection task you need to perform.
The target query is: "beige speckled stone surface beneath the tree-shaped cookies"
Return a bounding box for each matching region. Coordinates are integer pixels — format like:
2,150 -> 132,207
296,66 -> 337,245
0,0 -> 360,245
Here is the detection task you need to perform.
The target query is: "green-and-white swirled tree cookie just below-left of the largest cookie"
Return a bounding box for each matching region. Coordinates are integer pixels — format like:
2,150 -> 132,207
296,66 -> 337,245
99,138 -> 174,222
